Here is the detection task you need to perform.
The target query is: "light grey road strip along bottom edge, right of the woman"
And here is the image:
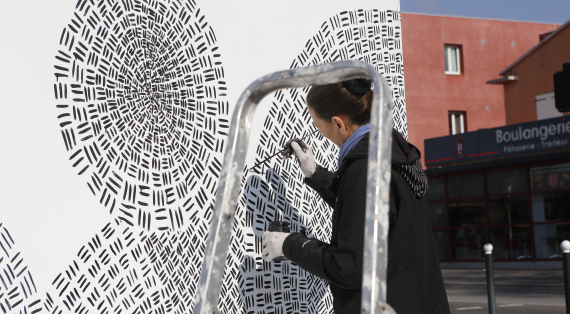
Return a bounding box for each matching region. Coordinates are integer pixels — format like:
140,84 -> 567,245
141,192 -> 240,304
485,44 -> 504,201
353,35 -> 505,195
447,290 -> 566,314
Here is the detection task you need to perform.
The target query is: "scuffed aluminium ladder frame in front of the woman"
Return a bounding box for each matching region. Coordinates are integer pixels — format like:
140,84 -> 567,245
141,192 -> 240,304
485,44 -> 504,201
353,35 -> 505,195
193,61 -> 395,314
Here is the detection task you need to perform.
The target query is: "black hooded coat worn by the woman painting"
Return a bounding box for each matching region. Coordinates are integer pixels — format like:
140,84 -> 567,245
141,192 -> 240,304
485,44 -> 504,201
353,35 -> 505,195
283,131 -> 449,314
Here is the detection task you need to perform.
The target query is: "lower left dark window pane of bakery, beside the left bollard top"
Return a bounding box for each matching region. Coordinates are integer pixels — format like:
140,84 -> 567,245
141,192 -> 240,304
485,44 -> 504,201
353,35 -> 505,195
450,228 -> 487,260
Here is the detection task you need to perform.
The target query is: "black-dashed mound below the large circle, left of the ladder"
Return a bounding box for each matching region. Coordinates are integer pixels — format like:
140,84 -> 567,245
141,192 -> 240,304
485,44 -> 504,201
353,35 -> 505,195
45,219 -> 207,313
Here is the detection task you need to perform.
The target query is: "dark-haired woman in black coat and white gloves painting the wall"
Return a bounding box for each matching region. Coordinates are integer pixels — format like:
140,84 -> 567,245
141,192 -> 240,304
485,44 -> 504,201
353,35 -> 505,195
263,79 -> 449,314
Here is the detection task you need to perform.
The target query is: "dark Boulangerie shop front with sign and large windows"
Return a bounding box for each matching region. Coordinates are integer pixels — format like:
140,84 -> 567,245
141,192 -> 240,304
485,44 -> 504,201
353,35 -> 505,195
425,118 -> 570,268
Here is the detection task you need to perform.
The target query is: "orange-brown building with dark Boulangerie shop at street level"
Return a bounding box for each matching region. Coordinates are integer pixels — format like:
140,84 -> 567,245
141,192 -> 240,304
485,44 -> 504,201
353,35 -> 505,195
418,17 -> 570,268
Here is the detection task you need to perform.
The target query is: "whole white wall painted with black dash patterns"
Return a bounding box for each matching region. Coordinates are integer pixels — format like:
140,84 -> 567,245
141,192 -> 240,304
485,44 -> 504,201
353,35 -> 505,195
0,0 -> 406,313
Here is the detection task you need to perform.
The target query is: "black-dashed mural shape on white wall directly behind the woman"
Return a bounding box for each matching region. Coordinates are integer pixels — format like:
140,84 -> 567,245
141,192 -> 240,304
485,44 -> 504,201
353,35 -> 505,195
221,10 -> 407,313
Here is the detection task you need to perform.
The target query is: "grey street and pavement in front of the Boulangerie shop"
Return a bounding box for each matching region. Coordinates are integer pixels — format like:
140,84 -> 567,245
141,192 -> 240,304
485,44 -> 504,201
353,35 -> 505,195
442,269 -> 566,314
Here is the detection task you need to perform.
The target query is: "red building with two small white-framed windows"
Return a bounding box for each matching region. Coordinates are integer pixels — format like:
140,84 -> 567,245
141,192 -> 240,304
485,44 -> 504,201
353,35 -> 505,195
402,13 -> 560,165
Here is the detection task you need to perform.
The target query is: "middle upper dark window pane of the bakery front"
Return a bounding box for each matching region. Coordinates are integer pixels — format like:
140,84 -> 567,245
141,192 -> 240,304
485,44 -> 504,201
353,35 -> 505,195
486,168 -> 527,195
